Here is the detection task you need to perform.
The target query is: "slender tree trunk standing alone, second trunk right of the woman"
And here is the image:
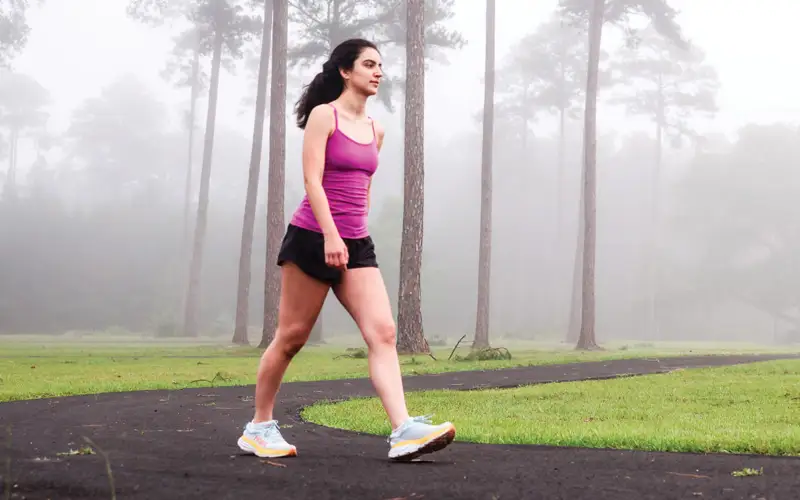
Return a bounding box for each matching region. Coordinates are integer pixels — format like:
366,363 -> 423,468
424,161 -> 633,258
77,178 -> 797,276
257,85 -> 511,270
472,0 -> 494,349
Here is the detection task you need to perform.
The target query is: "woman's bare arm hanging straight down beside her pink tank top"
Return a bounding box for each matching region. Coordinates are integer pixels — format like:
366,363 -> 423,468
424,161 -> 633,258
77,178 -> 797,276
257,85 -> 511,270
303,104 -> 348,267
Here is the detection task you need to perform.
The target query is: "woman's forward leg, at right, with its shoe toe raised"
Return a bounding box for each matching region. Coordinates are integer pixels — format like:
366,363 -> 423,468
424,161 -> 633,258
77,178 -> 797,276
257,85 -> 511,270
334,267 -> 456,460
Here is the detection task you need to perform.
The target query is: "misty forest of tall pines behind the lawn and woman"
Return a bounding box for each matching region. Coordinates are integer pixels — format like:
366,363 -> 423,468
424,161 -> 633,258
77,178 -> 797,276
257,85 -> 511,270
0,0 -> 800,352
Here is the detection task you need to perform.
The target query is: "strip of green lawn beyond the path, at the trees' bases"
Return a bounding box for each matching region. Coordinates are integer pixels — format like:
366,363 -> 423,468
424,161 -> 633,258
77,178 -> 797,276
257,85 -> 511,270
0,337 -> 792,402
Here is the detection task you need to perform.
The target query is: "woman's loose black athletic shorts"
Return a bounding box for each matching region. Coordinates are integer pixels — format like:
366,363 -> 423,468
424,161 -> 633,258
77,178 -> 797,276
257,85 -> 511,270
278,224 -> 378,285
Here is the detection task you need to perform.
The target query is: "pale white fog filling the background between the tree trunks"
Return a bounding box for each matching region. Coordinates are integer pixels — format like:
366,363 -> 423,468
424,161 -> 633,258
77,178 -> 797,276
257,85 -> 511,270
0,0 -> 800,344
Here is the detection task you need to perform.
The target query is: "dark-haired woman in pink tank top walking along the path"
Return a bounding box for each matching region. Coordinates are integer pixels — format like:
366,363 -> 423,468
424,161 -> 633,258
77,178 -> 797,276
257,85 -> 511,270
238,39 -> 455,460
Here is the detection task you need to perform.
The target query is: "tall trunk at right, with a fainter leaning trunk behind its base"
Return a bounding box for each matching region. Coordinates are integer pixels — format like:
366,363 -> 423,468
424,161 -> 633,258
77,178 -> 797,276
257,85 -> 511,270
576,0 -> 605,349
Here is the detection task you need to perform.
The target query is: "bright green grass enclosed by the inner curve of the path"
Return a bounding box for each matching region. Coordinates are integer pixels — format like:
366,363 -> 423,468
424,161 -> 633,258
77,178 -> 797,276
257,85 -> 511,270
303,360 -> 800,456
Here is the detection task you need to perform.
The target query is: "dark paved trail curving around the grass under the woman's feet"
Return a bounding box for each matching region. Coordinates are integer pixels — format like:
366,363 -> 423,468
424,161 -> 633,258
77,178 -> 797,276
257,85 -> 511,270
0,355 -> 800,500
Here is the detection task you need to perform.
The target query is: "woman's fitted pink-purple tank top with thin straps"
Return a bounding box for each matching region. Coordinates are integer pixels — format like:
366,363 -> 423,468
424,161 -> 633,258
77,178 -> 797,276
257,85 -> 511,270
291,105 -> 378,239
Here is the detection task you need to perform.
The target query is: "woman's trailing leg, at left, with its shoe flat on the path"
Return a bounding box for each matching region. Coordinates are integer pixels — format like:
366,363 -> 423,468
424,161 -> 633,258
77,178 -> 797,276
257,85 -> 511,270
238,262 -> 330,458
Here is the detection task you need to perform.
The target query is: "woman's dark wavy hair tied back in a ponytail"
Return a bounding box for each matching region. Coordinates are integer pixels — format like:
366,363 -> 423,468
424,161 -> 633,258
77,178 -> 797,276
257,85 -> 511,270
294,38 -> 378,128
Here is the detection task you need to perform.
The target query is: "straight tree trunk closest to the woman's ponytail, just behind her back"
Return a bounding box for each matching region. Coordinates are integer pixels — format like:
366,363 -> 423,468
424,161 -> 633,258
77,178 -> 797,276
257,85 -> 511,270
259,0 -> 289,348
